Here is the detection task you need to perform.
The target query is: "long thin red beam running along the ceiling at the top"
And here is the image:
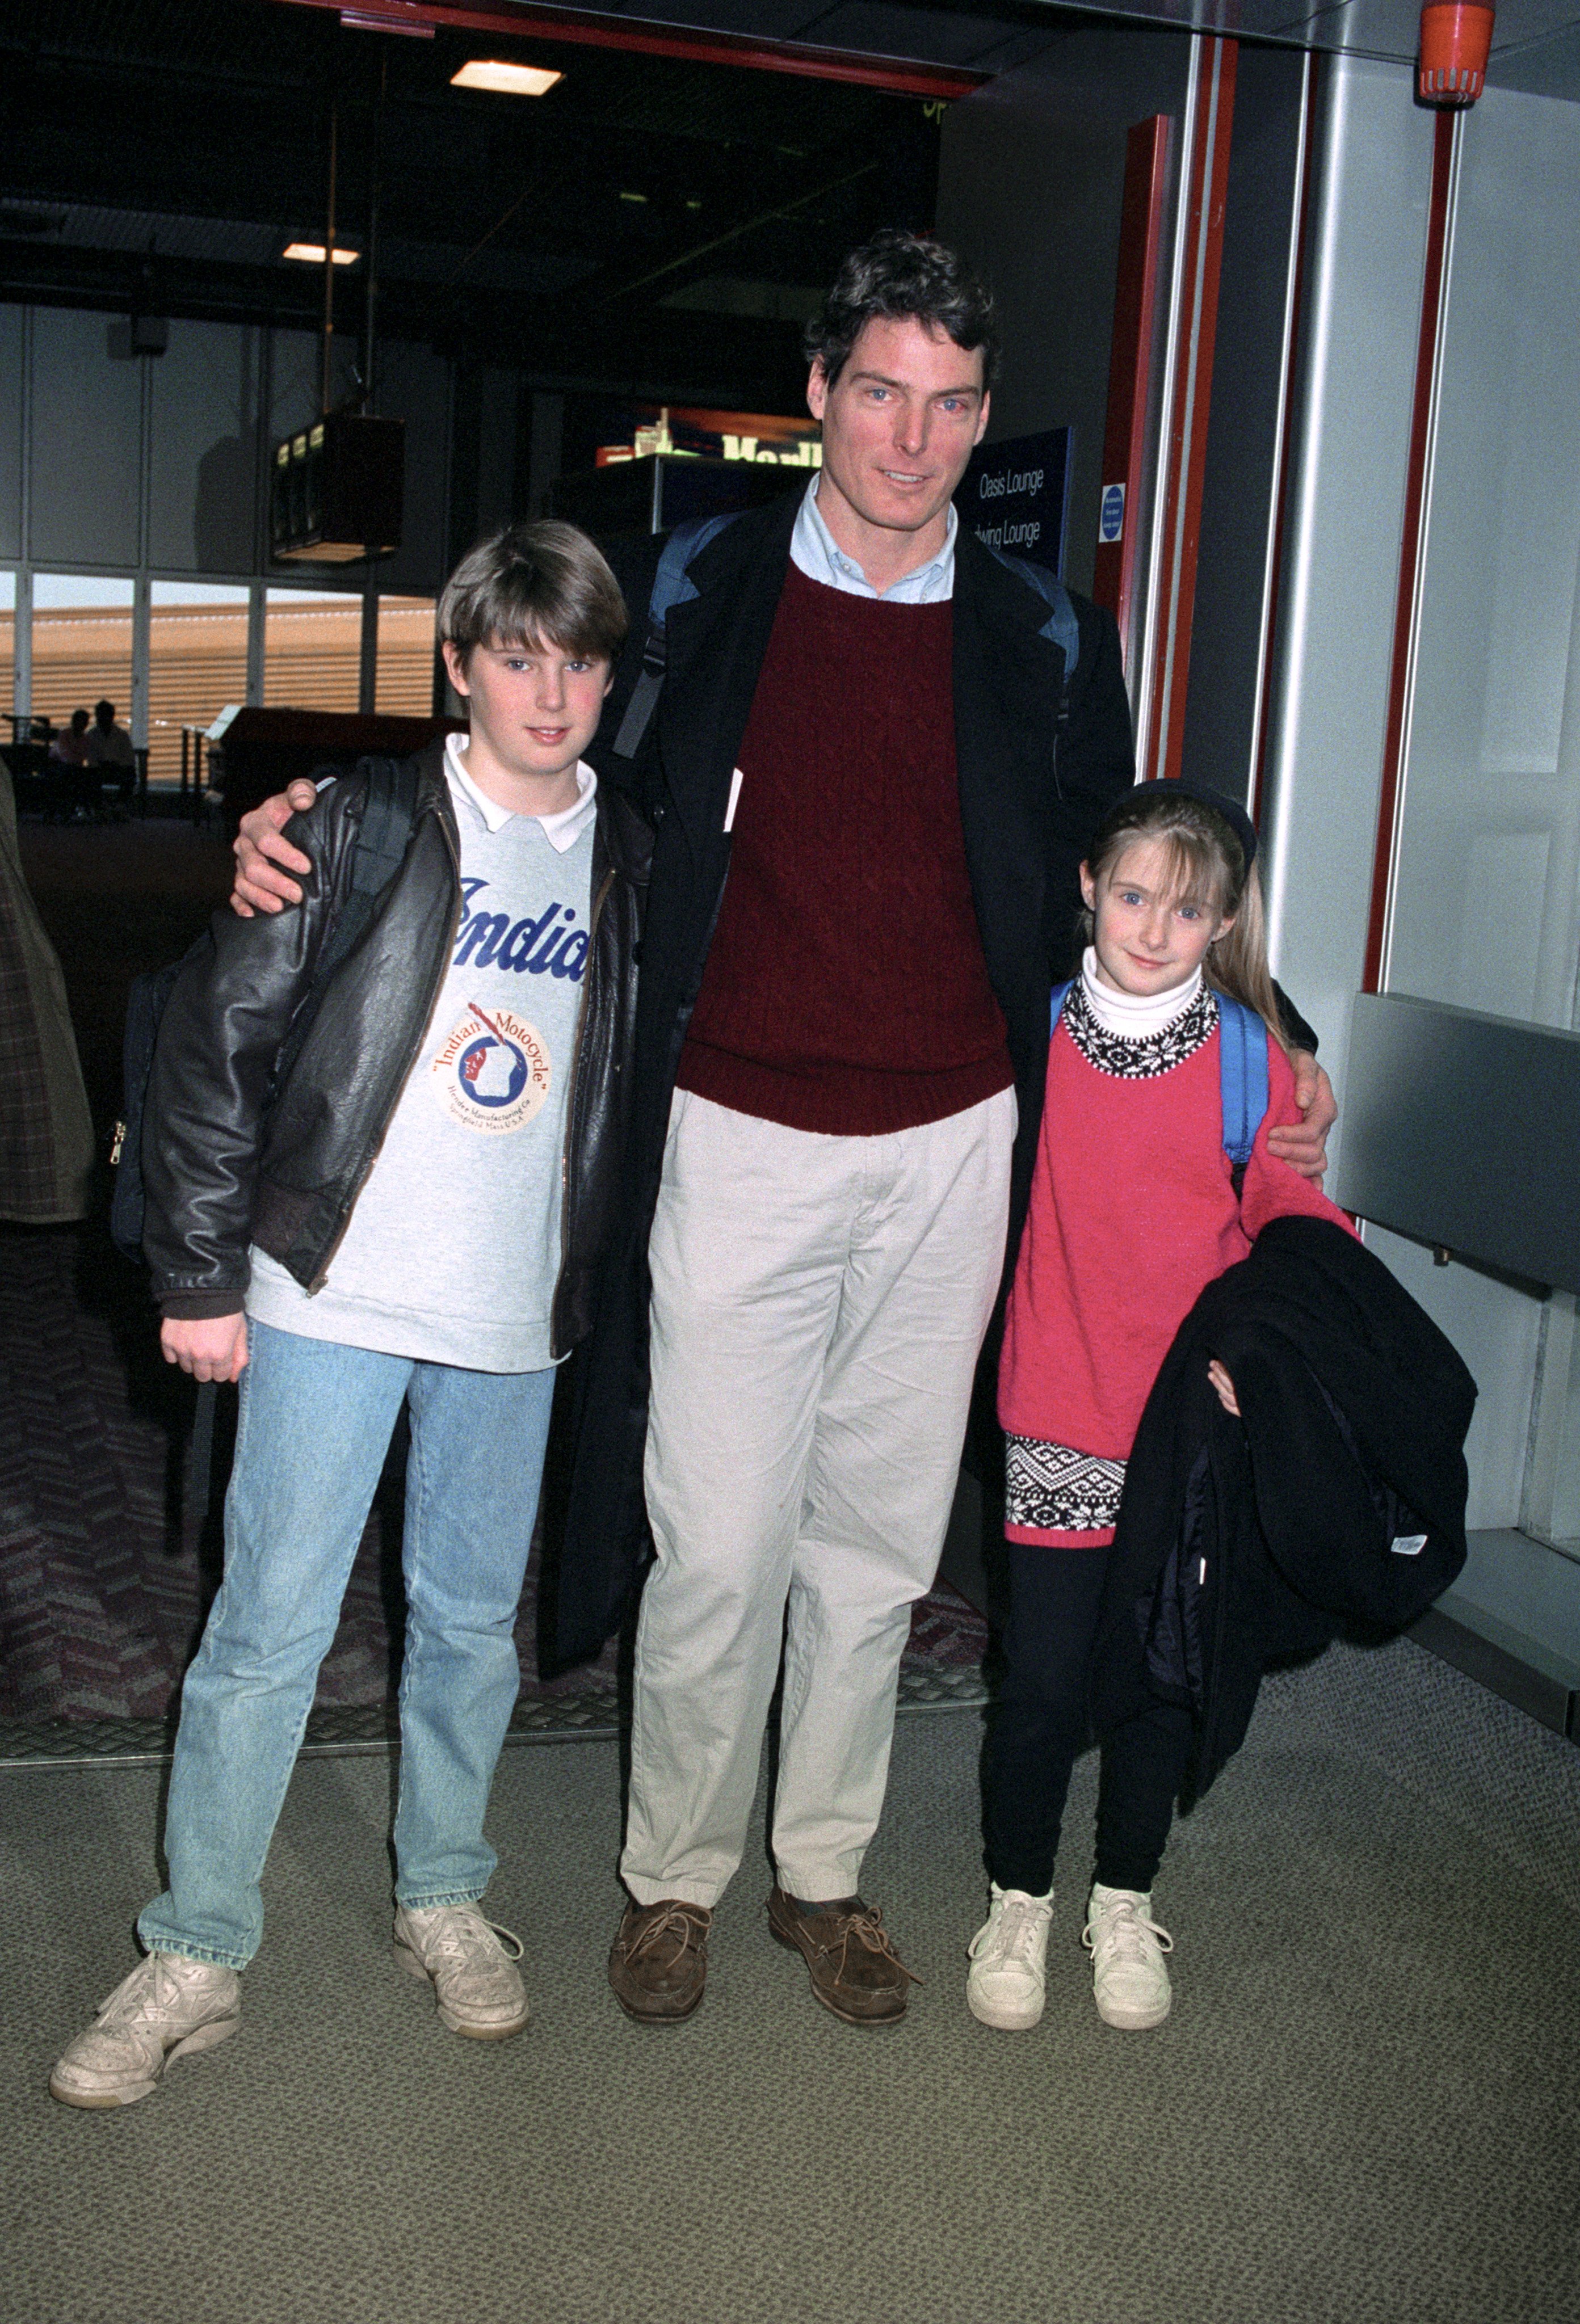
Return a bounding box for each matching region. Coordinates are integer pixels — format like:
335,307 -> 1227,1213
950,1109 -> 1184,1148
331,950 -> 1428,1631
279,0 -> 992,104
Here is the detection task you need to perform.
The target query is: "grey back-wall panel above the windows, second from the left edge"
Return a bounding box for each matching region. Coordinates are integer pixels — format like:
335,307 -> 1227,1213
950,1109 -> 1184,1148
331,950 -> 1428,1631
26,307 -> 144,567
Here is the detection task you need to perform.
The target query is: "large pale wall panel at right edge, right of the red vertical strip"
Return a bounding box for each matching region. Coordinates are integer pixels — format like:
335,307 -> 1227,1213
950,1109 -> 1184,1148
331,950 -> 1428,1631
1385,91 -> 1580,1025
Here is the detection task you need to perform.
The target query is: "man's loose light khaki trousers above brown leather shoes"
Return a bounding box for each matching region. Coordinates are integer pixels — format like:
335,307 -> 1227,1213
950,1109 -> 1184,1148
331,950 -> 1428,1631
620,1090 -> 1015,1906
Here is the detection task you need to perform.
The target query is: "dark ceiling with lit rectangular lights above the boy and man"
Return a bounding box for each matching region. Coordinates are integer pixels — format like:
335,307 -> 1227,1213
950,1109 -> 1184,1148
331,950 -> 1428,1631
0,0 -> 964,409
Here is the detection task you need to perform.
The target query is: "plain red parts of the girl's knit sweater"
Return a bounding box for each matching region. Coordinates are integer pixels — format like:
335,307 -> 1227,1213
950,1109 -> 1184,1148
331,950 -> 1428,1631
999,999 -> 1350,1546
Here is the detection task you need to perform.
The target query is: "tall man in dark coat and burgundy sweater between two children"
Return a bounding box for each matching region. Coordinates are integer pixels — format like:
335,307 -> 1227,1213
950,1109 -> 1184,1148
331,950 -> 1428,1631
244,233 -> 1331,2024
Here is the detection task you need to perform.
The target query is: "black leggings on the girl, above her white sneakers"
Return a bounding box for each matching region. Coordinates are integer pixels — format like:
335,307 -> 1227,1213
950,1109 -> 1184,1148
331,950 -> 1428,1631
983,1541 -> 1192,1896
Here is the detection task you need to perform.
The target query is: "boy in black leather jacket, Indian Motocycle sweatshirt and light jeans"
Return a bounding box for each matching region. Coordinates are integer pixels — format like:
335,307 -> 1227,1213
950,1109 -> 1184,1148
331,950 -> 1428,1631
49,523 -> 648,2106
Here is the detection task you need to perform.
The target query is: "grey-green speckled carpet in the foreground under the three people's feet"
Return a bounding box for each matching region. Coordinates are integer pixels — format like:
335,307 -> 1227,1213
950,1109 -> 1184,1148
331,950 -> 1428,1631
0,1643 -> 1580,2324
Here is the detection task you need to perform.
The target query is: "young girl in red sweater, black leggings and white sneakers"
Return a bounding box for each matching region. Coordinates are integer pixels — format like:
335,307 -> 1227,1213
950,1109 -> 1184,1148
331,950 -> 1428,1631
967,781 -> 1345,2029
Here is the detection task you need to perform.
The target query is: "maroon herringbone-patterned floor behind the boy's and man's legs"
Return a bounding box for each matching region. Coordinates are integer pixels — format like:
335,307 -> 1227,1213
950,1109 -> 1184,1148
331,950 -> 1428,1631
0,1222 -> 985,1724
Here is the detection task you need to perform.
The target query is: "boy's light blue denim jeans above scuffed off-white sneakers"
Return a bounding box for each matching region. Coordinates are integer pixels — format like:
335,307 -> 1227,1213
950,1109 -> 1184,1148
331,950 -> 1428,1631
137,1320 -> 555,1968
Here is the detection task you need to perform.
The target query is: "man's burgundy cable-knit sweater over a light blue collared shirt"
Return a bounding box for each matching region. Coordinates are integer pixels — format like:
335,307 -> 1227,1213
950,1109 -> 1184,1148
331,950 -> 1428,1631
678,565 -> 1013,1136
